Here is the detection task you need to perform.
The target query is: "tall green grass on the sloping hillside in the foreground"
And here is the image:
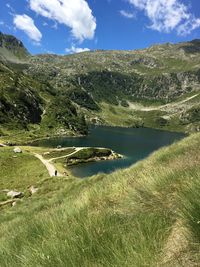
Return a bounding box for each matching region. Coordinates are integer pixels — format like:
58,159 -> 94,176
0,134 -> 200,267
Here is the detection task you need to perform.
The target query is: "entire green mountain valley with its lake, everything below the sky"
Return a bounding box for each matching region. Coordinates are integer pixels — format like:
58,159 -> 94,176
0,33 -> 200,267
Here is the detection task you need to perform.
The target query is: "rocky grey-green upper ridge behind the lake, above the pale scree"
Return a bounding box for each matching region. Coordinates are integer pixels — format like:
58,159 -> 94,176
28,40 -> 200,103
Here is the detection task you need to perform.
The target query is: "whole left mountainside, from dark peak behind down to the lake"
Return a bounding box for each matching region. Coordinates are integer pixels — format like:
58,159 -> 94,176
0,33 -> 87,138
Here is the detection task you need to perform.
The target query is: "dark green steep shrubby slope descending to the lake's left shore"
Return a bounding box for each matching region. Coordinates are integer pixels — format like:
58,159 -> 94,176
0,63 -> 87,137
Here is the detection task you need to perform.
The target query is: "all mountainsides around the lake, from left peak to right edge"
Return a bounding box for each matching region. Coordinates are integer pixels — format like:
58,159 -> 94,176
0,33 -> 200,140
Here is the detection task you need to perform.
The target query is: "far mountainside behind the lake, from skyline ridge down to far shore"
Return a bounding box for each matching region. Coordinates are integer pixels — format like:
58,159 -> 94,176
27,40 -> 200,131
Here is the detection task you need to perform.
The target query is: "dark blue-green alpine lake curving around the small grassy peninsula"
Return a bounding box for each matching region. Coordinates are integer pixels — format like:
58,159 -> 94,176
32,126 -> 185,178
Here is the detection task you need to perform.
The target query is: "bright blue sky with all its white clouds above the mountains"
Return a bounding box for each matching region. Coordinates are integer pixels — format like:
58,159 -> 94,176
0,0 -> 200,54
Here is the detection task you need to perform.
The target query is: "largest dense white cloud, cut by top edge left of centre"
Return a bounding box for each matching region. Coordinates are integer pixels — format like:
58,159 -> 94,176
29,0 -> 96,42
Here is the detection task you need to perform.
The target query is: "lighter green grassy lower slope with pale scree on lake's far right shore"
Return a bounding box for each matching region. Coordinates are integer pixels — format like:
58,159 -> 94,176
91,93 -> 200,132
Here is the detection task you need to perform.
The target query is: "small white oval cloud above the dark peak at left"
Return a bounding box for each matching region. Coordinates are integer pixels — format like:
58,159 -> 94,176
13,14 -> 42,43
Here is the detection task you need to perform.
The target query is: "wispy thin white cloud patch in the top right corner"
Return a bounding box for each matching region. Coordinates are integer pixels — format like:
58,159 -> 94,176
128,0 -> 200,35
